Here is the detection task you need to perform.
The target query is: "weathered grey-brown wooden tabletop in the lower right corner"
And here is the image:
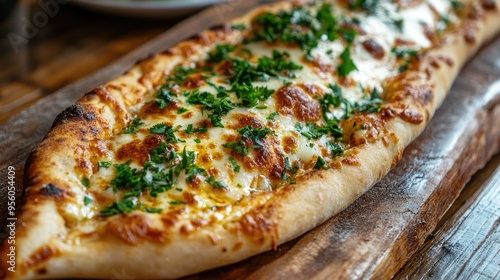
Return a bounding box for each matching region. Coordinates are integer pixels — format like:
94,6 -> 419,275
394,154 -> 500,280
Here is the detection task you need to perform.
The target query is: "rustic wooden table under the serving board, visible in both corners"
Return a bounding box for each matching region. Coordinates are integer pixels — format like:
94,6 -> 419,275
0,1 -> 500,279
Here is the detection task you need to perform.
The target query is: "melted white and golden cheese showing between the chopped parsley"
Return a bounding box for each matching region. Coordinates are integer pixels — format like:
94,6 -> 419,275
70,1 -> 460,223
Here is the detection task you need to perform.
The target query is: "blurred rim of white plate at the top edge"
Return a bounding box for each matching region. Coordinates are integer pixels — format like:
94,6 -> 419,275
71,0 -> 228,18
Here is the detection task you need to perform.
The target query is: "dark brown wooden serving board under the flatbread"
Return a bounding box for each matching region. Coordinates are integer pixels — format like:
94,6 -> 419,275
0,1 -> 500,279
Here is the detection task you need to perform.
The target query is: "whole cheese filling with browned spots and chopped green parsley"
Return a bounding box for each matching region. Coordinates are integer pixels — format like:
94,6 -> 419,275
66,0 -> 464,230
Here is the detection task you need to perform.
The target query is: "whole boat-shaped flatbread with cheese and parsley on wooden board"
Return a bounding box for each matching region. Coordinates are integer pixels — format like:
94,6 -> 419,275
1,0 -> 500,279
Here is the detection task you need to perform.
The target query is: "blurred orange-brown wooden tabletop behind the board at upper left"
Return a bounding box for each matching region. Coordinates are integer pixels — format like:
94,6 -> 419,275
0,0 -> 175,123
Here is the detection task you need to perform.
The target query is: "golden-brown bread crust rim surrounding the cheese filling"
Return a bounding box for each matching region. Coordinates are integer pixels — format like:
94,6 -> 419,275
1,0 -> 500,279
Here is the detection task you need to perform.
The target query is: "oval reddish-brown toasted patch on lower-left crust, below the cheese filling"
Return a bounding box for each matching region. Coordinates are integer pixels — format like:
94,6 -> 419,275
106,214 -> 168,245
